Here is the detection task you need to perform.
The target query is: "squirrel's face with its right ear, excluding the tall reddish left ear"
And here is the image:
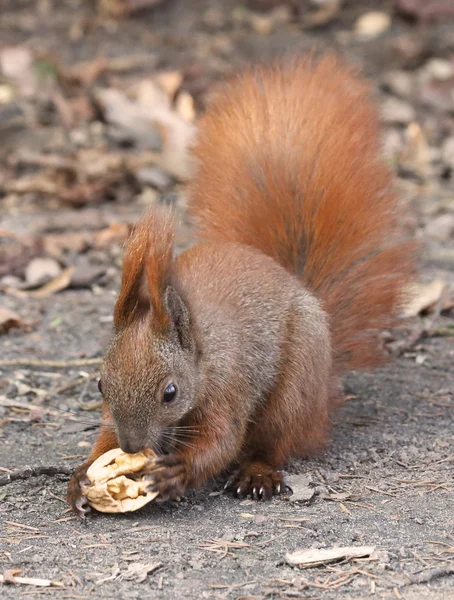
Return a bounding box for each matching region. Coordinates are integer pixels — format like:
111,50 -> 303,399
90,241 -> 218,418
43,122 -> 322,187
100,287 -> 198,453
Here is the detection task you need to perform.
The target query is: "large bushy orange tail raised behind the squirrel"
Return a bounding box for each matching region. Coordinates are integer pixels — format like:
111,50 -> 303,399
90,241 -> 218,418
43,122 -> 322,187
189,56 -> 413,371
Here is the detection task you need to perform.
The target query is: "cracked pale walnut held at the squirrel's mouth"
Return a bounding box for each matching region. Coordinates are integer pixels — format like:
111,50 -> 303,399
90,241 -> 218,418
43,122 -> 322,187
82,448 -> 158,513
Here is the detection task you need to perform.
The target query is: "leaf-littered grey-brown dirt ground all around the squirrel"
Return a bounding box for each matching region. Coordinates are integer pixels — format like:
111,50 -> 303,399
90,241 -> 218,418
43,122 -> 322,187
0,0 -> 454,600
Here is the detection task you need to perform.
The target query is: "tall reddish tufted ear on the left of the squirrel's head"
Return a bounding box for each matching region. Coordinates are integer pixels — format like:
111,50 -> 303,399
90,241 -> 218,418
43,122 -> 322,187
114,208 -> 174,328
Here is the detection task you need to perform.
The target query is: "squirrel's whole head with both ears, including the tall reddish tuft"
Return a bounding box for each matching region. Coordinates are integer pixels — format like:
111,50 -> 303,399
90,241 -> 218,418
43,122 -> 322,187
100,210 -> 199,453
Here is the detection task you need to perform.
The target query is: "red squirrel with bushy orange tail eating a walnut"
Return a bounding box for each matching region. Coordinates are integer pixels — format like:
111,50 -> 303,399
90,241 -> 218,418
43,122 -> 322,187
68,56 -> 414,514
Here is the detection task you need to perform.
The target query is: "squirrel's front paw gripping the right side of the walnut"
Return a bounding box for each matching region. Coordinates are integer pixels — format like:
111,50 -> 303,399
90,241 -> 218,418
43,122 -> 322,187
145,454 -> 190,502
